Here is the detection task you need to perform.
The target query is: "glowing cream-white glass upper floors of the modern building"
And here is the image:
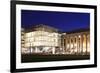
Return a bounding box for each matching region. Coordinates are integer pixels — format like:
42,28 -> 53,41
25,31 -> 60,48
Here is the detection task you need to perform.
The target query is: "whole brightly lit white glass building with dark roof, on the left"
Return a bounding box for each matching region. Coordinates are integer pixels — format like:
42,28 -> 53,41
22,24 -> 61,54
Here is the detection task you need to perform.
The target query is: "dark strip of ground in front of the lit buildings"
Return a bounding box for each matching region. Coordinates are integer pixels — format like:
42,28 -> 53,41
21,54 -> 90,63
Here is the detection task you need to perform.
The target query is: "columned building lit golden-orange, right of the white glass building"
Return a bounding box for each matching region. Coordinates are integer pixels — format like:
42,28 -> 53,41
62,29 -> 90,55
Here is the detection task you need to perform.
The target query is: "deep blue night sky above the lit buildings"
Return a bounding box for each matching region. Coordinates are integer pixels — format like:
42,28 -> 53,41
21,10 -> 90,32
